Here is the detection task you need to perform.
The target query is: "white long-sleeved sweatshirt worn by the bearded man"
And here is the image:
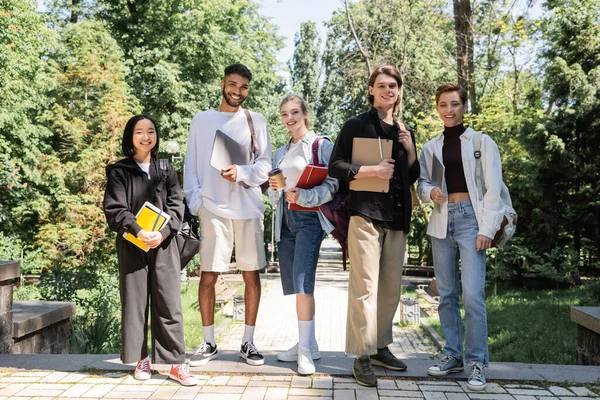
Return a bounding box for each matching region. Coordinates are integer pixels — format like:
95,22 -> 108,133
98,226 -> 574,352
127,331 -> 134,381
183,107 -> 271,219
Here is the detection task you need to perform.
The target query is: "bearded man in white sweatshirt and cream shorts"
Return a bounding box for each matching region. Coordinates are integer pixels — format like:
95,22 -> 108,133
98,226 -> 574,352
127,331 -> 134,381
184,64 -> 271,366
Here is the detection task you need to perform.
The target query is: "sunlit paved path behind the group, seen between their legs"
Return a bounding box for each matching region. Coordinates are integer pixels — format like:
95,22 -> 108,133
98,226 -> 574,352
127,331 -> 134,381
217,238 -> 436,355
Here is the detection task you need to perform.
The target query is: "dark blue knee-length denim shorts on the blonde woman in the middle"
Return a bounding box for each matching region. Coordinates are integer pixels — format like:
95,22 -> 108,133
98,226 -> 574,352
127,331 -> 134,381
277,202 -> 325,295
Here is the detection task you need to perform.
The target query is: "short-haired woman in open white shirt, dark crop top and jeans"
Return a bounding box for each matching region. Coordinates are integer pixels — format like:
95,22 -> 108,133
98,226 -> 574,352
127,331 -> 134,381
418,83 -> 504,390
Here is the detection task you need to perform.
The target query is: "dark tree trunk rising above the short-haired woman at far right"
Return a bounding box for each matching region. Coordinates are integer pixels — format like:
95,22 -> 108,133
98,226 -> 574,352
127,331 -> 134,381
453,0 -> 477,112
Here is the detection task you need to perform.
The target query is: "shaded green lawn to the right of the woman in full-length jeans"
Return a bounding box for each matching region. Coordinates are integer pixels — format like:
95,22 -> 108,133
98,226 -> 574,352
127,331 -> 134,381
429,285 -> 587,365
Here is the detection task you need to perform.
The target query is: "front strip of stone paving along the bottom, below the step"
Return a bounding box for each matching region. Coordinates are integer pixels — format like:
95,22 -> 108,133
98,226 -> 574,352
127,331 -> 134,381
0,370 -> 600,400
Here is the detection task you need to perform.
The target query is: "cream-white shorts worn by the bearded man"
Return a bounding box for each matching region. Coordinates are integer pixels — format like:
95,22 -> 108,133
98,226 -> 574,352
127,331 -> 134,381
198,207 -> 267,272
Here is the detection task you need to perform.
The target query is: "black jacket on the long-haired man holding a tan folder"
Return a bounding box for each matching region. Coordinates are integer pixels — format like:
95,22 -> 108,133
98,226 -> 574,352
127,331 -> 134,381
329,108 -> 420,233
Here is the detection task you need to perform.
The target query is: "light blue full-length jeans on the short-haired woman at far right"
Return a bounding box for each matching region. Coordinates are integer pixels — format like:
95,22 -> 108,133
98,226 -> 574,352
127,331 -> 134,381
431,200 -> 488,365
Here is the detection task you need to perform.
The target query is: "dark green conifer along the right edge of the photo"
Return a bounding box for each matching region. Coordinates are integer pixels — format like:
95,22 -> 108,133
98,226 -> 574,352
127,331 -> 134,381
536,0 -> 600,274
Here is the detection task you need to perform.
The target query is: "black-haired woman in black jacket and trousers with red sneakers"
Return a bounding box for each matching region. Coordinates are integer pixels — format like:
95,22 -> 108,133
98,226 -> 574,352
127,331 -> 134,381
104,115 -> 198,386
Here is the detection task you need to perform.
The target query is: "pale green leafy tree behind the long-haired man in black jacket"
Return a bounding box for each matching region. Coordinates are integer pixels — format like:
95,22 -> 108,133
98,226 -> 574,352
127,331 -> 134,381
319,0 -> 454,126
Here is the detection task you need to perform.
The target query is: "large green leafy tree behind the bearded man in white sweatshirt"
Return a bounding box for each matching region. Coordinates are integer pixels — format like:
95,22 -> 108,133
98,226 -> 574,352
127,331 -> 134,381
96,0 -> 282,151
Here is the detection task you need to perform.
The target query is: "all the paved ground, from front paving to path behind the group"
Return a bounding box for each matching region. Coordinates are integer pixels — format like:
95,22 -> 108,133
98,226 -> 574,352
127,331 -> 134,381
0,241 -> 600,400
